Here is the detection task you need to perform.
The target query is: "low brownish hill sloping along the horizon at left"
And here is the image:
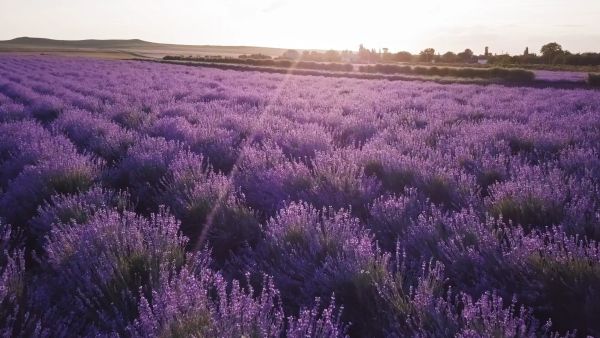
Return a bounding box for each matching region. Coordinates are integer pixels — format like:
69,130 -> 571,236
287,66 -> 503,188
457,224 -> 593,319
0,37 -> 294,58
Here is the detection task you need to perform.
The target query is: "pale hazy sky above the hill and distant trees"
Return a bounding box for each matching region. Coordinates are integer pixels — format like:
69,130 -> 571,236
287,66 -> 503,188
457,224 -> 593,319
0,0 -> 600,53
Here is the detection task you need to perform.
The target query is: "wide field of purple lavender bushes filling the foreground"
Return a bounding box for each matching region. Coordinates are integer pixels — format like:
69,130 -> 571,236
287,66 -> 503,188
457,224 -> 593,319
0,56 -> 600,337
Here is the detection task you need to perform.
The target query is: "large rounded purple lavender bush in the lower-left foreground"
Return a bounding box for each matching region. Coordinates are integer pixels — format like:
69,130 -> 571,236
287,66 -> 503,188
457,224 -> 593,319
44,211 -> 186,335
